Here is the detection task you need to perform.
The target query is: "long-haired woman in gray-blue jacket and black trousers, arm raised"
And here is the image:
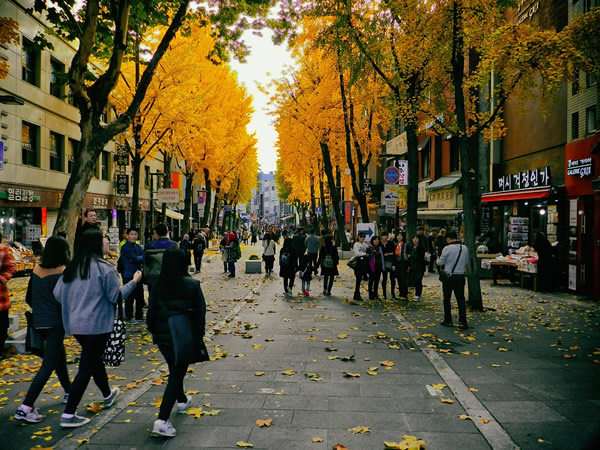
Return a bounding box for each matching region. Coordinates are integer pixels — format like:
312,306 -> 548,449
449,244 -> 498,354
54,229 -> 142,428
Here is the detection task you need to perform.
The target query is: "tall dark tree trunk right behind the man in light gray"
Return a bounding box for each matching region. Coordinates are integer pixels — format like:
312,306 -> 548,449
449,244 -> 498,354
450,1 -> 483,311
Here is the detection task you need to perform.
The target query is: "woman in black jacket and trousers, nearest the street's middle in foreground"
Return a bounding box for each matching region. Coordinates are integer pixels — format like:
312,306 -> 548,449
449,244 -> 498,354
146,247 -> 206,437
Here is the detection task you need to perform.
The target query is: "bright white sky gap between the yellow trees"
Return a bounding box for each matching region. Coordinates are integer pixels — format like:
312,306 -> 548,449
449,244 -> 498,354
231,30 -> 292,172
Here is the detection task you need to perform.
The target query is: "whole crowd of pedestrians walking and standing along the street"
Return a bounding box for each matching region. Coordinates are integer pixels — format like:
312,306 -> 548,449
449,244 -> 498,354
0,211 -> 469,437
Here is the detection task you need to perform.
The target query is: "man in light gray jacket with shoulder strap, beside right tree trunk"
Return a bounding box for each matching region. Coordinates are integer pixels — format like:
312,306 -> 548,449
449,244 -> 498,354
437,230 -> 469,329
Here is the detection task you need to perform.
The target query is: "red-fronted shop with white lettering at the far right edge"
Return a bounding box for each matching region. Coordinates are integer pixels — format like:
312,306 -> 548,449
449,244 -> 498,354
564,135 -> 600,301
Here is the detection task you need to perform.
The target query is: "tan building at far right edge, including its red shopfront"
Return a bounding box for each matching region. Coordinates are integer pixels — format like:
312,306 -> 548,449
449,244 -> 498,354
563,0 -> 600,300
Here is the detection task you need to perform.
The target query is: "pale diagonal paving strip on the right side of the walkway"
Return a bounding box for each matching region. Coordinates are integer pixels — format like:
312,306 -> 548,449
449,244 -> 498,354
390,311 -> 520,450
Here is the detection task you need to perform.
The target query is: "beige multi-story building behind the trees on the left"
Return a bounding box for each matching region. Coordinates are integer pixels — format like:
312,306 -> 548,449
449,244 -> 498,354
0,0 -> 180,245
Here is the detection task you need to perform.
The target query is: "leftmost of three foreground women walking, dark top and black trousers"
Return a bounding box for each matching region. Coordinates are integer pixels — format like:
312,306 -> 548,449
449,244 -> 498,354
15,236 -> 71,423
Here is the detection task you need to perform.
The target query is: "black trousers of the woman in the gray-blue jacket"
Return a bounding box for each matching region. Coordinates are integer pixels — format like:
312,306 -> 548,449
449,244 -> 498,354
65,333 -> 110,414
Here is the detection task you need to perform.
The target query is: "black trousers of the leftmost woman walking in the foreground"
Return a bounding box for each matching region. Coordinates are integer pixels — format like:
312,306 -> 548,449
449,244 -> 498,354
23,326 -> 71,407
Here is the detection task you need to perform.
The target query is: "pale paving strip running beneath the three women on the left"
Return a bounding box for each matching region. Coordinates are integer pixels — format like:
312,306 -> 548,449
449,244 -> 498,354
54,280 -> 264,450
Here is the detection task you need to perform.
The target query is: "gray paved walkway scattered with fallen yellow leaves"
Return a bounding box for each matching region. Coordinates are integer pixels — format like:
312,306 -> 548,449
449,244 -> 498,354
0,247 -> 600,449
